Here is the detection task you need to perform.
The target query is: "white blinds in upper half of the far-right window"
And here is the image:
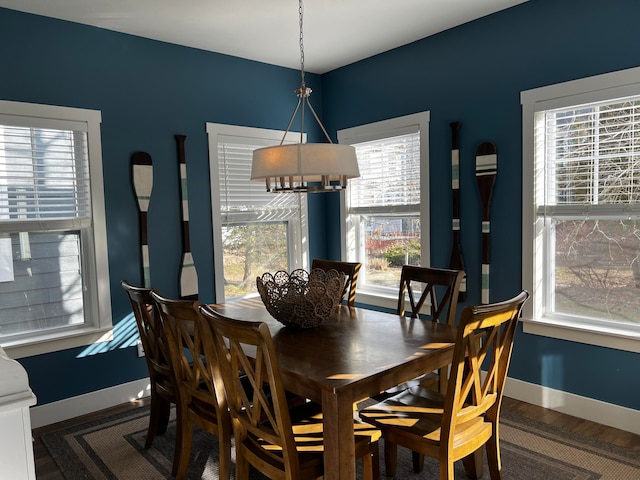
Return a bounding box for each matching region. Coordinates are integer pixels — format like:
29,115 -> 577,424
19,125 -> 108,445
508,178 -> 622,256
537,97 -> 640,211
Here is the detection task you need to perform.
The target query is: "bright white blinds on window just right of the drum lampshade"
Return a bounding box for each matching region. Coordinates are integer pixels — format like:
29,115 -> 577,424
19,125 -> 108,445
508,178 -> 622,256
348,132 -> 420,213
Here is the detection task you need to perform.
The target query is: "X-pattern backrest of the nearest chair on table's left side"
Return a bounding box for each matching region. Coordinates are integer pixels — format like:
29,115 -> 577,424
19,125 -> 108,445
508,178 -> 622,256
200,305 -> 300,478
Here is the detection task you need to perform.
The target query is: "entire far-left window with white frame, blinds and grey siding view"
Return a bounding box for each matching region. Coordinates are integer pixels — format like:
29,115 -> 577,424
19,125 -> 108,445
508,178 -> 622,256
0,101 -> 112,358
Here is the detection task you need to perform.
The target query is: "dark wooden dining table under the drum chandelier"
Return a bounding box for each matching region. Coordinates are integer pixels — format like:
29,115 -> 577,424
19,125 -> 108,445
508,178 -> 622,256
211,298 -> 456,480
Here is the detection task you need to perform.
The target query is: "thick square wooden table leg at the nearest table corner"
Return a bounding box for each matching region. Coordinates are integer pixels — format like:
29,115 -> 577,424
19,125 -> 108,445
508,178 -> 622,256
322,390 -> 356,480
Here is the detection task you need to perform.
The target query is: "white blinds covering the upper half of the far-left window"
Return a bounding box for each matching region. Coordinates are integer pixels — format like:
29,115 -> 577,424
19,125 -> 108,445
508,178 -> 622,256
0,120 -> 91,223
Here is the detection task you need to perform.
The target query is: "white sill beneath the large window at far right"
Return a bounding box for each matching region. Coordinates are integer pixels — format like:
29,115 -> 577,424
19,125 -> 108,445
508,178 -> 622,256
522,318 -> 640,352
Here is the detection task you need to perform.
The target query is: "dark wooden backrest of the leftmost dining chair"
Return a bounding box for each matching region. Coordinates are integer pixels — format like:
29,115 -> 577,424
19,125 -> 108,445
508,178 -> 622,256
120,280 -> 176,401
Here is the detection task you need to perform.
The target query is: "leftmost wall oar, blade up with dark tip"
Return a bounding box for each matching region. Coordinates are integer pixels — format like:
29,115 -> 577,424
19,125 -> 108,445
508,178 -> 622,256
131,152 -> 153,288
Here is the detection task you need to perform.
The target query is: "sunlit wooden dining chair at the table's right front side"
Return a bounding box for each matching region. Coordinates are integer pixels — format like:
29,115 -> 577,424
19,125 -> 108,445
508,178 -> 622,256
360,290 -> 529,480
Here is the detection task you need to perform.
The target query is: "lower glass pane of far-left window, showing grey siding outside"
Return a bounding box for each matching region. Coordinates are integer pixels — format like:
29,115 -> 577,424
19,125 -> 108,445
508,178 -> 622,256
0,232 -> 84,338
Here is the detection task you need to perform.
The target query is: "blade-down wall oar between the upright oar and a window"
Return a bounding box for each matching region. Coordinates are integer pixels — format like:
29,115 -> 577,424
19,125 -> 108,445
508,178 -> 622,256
175,135 -> 198,300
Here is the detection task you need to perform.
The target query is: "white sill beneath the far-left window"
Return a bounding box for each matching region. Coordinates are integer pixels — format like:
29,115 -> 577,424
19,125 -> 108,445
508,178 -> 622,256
2,327 -> 113,359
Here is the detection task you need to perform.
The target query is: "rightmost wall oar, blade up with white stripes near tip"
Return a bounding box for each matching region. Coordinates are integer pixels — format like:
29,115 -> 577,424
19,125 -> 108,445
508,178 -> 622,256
476,142 -> 498,304
